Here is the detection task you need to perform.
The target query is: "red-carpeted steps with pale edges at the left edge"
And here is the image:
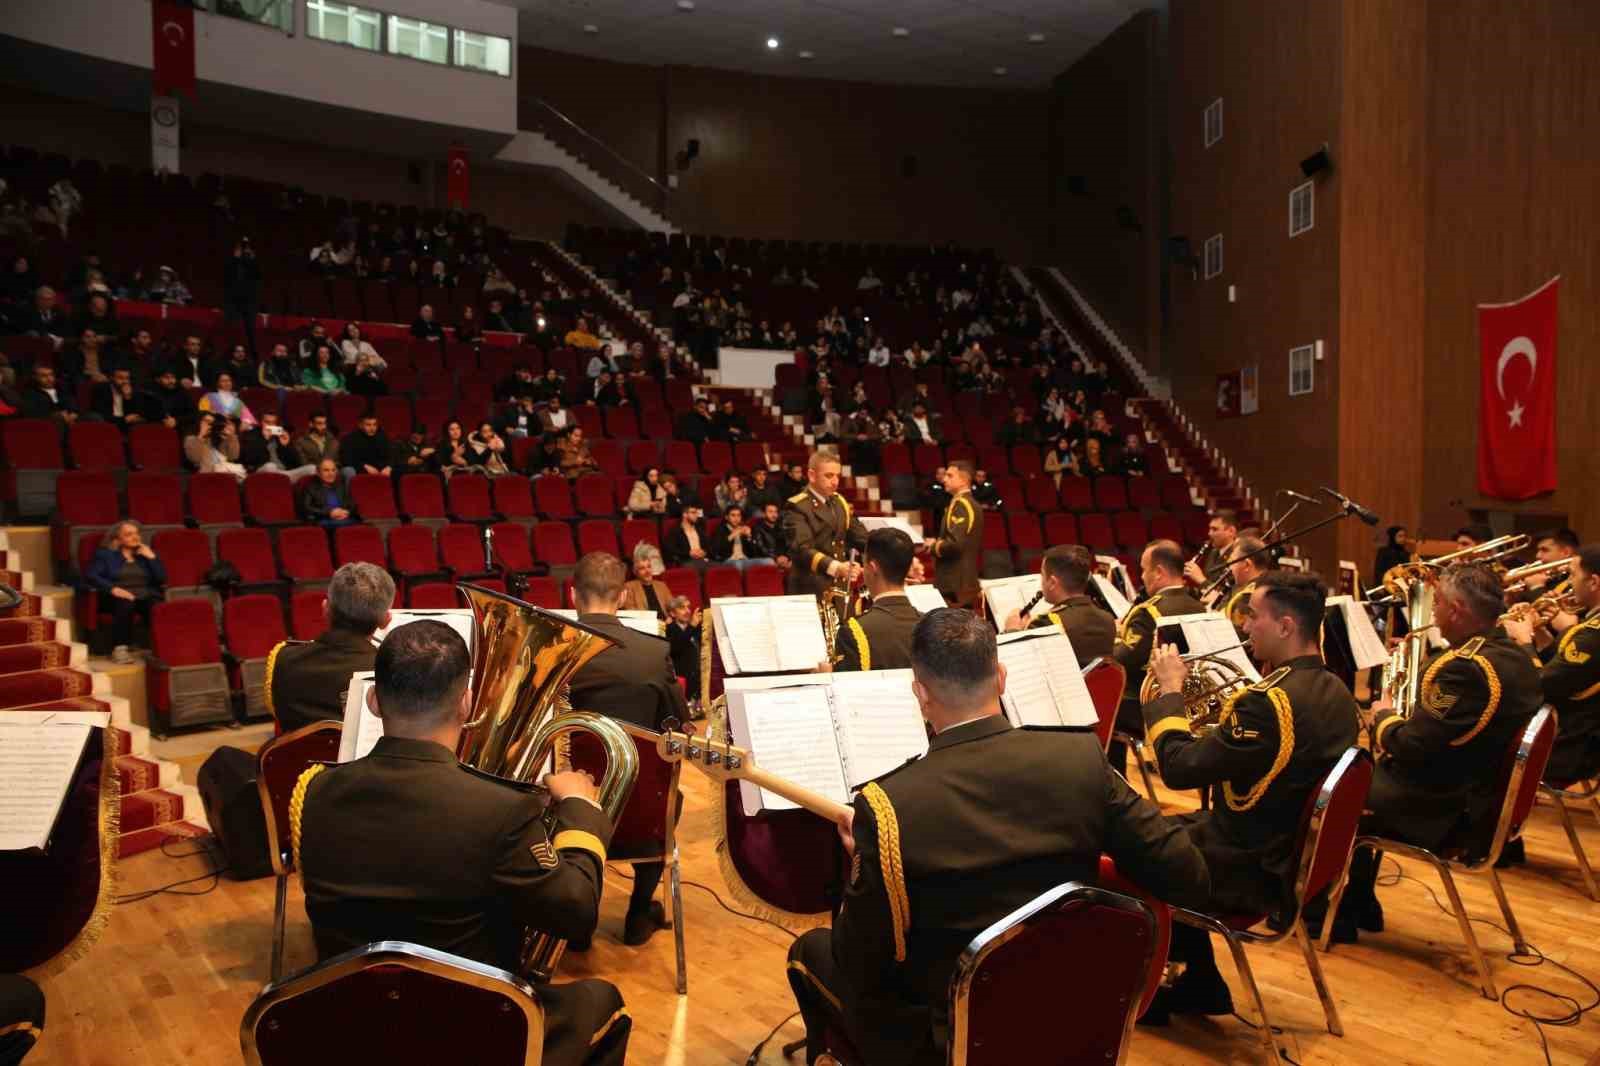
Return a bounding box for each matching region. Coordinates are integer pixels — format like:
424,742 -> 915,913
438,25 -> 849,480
0,527 -> 210,858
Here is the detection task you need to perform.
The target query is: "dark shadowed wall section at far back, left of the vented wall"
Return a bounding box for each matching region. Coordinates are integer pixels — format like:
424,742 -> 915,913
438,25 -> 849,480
1045,11 -> 1166,370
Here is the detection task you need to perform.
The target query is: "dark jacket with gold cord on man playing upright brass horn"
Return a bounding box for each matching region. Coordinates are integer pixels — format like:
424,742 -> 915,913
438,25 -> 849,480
1366,627 -> 1544,847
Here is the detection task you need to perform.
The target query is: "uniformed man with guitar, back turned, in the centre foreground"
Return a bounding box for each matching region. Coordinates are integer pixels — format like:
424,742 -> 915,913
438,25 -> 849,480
789,608 -> 1208,1066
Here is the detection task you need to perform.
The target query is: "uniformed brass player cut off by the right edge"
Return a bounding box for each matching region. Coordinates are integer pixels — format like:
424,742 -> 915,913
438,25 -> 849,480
1506,544 -> 1600,784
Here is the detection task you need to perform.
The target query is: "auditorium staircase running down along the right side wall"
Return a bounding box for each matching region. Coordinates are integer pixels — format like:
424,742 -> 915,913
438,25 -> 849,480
1013,266 -> 1266,525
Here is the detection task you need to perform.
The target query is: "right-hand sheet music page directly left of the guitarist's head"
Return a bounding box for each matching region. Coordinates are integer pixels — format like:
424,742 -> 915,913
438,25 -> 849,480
830,671 -> 928,789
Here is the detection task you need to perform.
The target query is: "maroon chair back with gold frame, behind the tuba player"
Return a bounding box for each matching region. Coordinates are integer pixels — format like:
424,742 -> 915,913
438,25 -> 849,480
238,941 -> 544,1066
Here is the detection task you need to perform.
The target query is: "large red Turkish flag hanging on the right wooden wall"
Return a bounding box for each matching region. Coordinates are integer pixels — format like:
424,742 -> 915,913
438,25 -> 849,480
1478,277 -> 1562,499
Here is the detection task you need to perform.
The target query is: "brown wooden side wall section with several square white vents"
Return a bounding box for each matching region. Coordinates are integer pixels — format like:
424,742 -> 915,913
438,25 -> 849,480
1166,0 -> 1346,570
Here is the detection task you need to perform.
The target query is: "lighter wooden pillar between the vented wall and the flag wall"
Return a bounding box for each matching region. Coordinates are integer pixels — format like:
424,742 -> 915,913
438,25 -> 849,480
1318,0 -> 1438,581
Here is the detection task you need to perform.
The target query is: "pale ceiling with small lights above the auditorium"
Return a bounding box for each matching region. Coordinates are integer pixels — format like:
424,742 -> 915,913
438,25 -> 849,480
510,0 -> 1165,88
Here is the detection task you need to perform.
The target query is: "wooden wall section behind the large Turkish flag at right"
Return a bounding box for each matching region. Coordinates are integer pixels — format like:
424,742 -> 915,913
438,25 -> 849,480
1422,0 -> 1600,541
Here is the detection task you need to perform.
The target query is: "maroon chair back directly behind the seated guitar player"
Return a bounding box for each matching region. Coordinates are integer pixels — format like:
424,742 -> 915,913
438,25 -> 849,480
947,882 -> 1157,1066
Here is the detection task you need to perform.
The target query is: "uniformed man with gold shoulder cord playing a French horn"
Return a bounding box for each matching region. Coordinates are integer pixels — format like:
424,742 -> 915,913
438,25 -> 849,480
1142,573 -> 1360,1024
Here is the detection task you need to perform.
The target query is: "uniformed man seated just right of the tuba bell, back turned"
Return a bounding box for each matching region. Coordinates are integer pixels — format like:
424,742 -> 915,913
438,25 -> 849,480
570,552 -> 690,951
